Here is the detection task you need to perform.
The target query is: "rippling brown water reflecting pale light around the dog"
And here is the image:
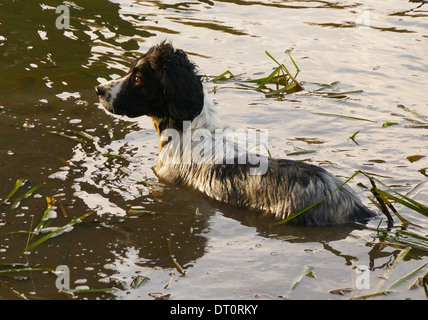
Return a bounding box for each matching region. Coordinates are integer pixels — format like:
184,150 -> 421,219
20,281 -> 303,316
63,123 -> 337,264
0,0 -> 428,299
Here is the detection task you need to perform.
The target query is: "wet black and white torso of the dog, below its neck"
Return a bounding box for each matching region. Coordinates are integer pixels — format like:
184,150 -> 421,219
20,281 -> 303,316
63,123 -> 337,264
157,158 -> 375,225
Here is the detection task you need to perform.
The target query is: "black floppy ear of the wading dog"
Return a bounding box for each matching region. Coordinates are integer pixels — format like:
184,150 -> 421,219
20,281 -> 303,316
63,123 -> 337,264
156,43 -> 204,129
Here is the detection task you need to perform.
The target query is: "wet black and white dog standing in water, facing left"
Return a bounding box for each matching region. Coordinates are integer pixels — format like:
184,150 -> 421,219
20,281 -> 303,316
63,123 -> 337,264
95,41 -> 375,225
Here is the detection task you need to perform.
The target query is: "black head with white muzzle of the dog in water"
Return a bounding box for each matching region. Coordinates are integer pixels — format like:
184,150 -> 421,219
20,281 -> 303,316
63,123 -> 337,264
96,42 -> 204,129
